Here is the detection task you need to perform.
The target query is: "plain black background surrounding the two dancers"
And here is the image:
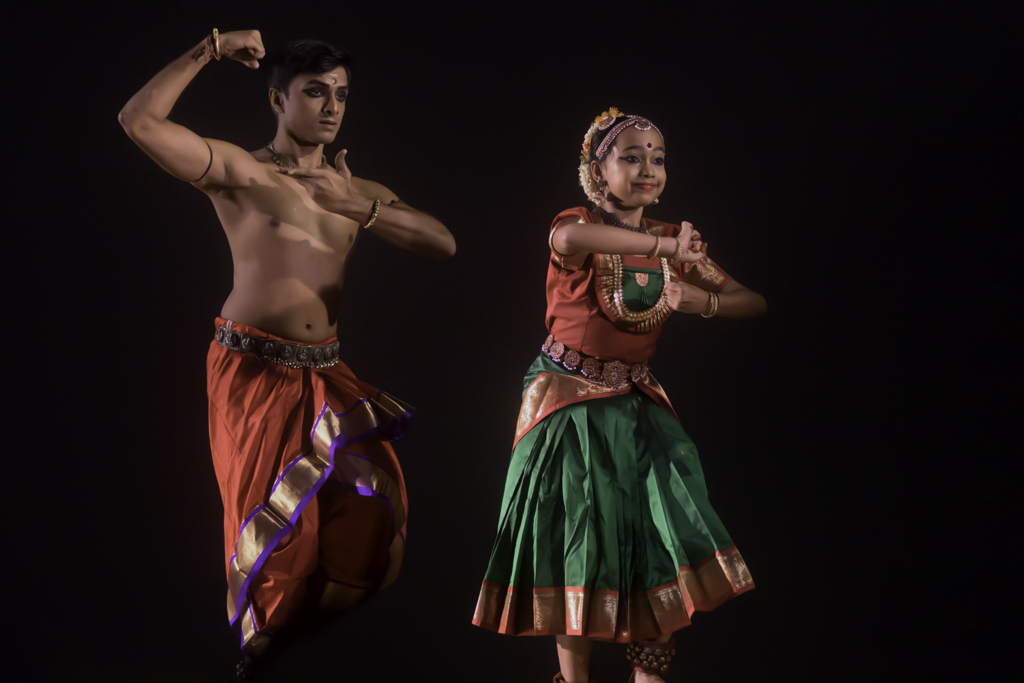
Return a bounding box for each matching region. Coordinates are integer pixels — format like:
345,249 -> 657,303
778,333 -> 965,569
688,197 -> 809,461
2,2 -> 1024,682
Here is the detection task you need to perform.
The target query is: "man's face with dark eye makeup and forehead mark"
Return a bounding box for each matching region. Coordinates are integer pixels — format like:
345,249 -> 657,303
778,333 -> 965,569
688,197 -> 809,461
270,67 -> 348,145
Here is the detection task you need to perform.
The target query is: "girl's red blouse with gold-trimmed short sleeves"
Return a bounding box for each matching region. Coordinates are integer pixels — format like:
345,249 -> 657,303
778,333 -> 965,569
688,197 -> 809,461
546,207 -> 729,364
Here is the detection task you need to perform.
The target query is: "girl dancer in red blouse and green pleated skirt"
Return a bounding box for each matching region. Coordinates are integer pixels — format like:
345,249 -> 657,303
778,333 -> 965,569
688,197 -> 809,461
473,108 -> 766,683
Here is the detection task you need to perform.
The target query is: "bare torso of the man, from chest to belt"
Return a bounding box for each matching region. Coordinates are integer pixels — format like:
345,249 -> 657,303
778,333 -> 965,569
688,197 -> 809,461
207,150 -> 359,342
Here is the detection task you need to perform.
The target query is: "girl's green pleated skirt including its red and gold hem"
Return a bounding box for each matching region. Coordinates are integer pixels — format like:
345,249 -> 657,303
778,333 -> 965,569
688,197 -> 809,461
473,355 -> 754,642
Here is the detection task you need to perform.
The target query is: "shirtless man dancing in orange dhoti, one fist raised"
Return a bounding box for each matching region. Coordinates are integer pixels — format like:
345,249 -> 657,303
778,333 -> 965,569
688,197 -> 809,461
118,29 -> 455,677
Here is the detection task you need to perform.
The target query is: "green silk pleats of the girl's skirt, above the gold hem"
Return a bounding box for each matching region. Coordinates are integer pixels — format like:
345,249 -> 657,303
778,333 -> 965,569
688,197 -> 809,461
484,354 -> 733,594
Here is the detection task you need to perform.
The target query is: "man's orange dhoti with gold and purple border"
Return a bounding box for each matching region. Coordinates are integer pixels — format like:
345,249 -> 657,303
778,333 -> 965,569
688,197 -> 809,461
207,318 -> 413,652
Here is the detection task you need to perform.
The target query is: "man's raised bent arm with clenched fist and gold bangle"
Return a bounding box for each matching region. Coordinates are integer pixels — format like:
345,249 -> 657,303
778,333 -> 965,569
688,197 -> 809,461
118,31 -> 264,188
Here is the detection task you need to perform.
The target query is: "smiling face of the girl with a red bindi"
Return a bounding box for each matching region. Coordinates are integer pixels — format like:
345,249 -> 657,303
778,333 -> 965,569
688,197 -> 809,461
591,126 -> 666,209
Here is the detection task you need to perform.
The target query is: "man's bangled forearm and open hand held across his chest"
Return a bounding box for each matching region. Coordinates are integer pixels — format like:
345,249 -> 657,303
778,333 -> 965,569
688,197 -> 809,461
274,150 -> 455,259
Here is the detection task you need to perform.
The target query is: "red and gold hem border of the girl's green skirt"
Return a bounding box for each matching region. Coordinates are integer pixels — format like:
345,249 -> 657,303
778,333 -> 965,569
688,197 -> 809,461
473,546 -> 754,642
